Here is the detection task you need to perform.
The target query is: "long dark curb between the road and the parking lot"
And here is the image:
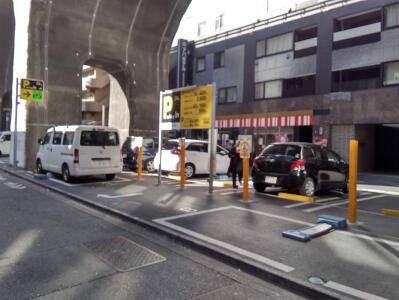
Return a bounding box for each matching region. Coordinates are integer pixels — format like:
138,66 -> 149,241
0,167 -> 350,300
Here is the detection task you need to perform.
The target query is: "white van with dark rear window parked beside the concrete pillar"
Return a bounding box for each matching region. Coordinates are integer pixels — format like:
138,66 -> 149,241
36,125 -> 122,182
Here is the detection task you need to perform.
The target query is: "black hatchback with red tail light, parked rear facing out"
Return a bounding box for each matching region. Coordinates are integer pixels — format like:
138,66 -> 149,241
252,143 -> 348,196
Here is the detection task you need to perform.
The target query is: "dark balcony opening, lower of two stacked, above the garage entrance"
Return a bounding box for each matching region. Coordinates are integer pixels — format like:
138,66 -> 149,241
332,66 -> 381,92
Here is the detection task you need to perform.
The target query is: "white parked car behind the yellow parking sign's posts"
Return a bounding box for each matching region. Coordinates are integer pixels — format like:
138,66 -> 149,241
154,139 -> 230,178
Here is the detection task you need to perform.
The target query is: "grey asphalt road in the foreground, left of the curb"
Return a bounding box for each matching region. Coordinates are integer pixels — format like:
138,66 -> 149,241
0,171 -> 310,300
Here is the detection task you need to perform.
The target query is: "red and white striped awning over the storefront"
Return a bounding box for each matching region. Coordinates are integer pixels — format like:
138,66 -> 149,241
215,111 -> 313,128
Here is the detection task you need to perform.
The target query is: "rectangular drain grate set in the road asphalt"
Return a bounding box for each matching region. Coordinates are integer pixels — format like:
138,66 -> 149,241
83,236 -> 166,272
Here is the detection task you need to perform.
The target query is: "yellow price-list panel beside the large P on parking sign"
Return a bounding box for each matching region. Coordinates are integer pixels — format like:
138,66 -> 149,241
180,85 -> 213,129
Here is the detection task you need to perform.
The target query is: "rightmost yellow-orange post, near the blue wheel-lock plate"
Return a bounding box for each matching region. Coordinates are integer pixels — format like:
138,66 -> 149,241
348,140 -> 359,223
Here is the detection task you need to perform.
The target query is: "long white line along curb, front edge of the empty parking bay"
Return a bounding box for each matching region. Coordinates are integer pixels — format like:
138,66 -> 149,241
154,219 -> 295,273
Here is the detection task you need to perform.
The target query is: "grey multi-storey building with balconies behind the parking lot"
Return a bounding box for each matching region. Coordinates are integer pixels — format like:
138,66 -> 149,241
170,0 -> 399,172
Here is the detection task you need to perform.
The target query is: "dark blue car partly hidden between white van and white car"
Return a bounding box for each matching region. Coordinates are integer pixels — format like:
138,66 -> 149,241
122,136 -> 158,172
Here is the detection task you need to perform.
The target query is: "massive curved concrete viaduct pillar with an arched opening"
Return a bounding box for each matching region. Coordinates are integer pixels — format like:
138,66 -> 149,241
9,0 -> 190,168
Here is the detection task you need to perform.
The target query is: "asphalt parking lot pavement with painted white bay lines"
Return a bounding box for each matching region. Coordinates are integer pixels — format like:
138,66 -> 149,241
0,164 -> 399,299
